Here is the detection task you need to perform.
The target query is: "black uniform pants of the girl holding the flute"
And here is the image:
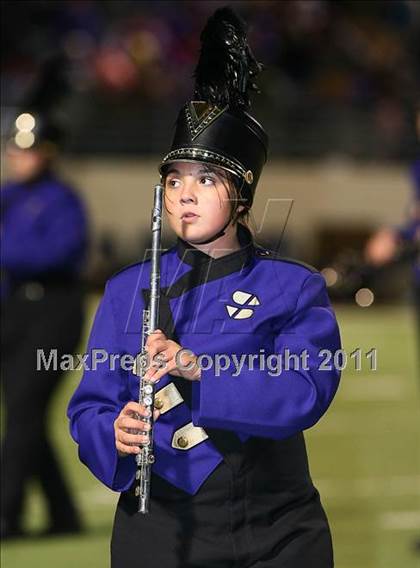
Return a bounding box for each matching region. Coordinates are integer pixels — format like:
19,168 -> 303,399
111,441 -> 334,568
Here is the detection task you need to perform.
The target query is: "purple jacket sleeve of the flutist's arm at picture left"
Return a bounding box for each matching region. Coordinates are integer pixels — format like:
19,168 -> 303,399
67,282 -> 136,491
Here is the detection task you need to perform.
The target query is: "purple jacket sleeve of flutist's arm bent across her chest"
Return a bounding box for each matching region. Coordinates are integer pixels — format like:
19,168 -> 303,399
193,273 -> 340,439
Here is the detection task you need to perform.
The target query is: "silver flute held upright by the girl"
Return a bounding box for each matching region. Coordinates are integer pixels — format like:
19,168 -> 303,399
135,184 -> 163,514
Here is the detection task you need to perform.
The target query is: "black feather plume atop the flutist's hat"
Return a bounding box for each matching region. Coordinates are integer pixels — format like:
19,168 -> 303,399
194,6 -> 263,109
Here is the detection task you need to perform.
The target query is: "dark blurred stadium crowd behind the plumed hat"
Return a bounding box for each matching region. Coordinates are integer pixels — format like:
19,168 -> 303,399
2,0 -> 420,159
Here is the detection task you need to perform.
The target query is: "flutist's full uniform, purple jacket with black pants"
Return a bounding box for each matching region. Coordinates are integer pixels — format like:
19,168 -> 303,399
68,225 -> 340,568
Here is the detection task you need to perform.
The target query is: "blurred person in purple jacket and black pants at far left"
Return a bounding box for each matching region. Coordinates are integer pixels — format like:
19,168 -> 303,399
1,113 -> 88,538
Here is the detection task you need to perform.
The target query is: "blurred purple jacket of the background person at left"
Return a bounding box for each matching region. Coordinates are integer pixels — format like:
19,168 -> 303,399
1,172 -> 88,298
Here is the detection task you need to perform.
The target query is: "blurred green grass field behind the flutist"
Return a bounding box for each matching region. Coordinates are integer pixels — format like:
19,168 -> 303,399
1,301 -> 420,568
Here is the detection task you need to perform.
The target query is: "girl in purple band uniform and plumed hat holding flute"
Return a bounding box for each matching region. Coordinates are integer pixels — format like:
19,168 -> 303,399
68,8 -> 340,568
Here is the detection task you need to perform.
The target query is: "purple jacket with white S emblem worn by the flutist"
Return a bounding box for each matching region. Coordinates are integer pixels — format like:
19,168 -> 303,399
68,227 -> 340,495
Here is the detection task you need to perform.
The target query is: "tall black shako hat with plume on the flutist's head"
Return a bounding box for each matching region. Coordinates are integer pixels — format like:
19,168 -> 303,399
159,7 -> 268,207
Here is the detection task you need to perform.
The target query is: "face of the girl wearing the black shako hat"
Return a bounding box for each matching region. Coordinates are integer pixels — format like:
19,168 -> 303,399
165,162 -> 243,244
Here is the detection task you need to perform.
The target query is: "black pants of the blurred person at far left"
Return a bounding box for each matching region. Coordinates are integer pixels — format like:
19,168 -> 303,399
1,283 -> 83,531
